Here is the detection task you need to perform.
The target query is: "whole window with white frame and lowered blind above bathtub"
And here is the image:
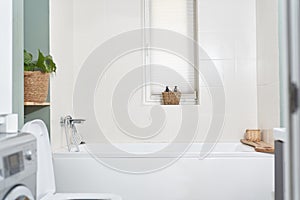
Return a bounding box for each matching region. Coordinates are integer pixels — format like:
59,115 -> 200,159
144,0 -> 198,104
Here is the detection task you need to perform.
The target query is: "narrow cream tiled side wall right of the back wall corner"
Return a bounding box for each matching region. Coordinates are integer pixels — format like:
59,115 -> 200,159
257,0 -> 280,130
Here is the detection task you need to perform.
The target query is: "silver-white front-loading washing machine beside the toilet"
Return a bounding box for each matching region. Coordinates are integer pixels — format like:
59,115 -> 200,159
0,133 -> 37,200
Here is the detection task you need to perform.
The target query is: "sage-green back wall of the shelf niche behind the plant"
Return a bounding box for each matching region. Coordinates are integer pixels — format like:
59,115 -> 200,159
24,0 -> 50,131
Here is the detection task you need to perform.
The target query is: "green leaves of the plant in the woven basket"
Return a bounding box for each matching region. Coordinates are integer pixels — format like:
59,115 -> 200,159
24,49 -> 56,73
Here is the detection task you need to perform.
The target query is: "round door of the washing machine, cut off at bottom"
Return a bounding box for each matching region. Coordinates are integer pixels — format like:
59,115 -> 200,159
3,185 -> 34,200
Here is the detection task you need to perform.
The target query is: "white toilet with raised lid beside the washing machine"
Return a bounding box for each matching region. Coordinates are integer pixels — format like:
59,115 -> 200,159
22,120 -> 121,200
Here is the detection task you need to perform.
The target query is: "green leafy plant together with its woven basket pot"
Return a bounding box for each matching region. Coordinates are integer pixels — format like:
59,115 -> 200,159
24,50 -> 56,103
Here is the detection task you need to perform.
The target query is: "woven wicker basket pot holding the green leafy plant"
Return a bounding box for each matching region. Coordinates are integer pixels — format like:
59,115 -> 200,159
24,71 -> 49,103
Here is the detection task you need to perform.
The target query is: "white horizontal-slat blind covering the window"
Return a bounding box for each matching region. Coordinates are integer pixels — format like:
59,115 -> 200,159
148,0 -> 197,94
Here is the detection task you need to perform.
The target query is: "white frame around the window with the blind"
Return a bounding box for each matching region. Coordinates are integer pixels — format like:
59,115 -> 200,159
142,0 -> 199,105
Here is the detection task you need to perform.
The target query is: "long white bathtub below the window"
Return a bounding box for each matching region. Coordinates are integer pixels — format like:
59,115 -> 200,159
54,143 -> 274,200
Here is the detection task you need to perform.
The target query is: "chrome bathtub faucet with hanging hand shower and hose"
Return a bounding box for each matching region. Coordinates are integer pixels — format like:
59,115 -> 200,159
60,115 -> 86,152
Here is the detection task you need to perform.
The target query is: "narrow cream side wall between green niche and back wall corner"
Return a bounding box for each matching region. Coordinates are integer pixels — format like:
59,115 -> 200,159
50,0 -> 74,146
